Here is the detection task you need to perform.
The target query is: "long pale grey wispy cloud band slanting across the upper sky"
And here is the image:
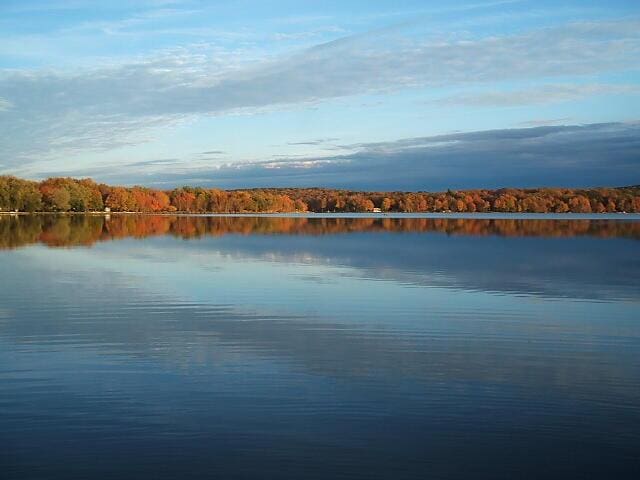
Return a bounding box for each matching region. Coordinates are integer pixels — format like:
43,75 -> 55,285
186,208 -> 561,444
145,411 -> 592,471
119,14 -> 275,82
0,20 -> 640,171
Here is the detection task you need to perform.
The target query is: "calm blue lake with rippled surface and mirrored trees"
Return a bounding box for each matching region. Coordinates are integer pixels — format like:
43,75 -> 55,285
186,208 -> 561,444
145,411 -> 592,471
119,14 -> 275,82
0,215 -> 640,480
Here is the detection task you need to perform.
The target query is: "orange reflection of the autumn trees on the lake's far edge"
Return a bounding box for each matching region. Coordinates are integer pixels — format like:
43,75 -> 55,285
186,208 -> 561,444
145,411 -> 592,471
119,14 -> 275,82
0,215 -> 640,250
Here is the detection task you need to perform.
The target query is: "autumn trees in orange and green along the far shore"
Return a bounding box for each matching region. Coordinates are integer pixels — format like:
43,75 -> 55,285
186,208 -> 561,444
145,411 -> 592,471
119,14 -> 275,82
0,176 -> 640,213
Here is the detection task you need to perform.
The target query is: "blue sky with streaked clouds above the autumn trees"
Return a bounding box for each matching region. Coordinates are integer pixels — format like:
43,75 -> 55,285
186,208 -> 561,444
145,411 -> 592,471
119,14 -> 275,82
0,0 -> 640,190
